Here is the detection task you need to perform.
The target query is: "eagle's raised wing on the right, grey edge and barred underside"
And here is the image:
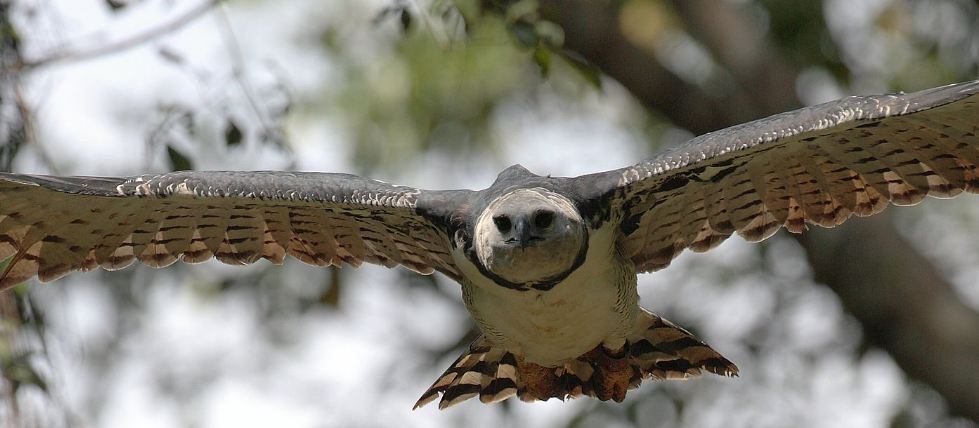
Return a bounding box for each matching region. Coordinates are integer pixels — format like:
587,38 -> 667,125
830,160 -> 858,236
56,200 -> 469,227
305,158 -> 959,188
581,81 -> 979,271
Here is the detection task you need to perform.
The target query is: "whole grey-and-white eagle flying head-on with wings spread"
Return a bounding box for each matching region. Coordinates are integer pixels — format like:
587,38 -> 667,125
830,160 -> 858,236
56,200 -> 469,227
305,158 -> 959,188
0,81 -> 979,409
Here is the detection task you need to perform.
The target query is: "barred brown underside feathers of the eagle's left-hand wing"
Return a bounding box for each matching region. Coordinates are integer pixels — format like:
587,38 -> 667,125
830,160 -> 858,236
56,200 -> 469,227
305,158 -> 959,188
0,172 -> 459,289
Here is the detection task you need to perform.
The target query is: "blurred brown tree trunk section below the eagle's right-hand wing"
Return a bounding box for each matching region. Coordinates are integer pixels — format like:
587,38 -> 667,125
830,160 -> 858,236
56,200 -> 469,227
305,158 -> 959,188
799,216 -> 979,421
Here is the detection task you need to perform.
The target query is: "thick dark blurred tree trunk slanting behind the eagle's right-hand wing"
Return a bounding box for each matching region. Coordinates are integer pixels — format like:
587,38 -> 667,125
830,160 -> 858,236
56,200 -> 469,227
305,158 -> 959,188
516,0 -> 979,421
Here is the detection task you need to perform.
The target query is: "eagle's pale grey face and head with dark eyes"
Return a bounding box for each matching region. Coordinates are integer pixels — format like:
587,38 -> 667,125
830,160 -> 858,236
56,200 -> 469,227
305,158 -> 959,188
473,188 -> 588,285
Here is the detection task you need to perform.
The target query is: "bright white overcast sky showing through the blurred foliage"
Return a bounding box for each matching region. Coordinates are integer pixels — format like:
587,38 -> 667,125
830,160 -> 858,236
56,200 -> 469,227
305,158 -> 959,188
0,0 -> 979,427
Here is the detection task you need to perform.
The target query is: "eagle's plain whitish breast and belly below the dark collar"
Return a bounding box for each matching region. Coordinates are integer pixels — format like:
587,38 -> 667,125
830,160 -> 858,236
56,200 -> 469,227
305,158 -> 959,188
453,224 -> 639,366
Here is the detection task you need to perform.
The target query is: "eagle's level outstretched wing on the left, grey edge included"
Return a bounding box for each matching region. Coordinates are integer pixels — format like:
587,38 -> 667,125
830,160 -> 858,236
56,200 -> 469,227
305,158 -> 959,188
0,172 -> 467,290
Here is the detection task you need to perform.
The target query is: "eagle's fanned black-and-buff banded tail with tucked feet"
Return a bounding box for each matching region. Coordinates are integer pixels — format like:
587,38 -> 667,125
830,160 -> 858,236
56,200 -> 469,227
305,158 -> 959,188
414,310 -> 738,410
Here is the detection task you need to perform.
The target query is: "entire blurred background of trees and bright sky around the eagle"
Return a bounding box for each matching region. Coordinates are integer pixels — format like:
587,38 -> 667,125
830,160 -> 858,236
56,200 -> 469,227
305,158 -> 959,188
0,0 -> 979,428
